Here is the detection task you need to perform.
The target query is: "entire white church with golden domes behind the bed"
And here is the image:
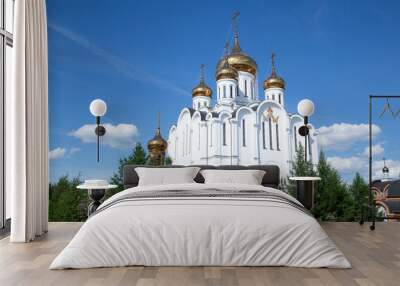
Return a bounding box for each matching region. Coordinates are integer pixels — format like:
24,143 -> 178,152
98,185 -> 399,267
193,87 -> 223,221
168,24 -> 318,178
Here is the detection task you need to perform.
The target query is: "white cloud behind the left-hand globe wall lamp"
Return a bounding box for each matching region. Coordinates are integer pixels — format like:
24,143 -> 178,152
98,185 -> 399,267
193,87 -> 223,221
69,123 -> 139,149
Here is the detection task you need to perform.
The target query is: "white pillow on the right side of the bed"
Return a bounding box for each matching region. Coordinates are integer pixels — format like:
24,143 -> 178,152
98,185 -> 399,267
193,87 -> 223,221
200,170 -> 265,185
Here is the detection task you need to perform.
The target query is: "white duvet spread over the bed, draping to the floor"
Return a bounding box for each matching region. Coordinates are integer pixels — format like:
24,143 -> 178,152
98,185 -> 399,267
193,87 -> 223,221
50,183 -> 351,269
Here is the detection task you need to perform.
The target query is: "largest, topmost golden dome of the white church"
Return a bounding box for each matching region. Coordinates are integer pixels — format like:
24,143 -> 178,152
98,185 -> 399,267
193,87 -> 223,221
217,35 -> 257,75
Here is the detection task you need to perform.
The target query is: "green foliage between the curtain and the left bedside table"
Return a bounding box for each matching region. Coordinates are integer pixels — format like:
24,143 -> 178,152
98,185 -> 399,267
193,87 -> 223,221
49,175 -> 87,221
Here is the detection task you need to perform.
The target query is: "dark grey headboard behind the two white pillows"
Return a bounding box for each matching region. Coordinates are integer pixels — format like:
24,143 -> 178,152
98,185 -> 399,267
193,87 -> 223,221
123,165 -> 280,189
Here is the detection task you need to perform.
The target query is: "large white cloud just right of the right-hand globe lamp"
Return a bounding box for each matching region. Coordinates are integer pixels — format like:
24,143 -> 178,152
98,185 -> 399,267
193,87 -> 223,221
318,123 -> 381,150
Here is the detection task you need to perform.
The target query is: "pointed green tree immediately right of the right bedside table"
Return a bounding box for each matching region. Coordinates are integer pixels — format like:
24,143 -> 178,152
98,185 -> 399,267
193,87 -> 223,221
313,151 -> 354,221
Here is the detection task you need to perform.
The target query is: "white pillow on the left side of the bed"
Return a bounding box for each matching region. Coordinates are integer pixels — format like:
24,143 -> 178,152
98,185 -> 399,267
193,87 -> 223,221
135,167 -> 200,186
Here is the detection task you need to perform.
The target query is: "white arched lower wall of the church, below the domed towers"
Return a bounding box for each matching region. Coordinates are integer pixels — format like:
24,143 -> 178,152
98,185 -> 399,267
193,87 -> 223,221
168,103 -> 318,181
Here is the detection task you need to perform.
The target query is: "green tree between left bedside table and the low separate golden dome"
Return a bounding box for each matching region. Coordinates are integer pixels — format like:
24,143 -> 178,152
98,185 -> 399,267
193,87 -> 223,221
106,143 -> 147,197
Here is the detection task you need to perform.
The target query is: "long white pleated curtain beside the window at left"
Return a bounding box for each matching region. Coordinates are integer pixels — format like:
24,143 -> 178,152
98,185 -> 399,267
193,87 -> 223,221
6,0 -> 49,242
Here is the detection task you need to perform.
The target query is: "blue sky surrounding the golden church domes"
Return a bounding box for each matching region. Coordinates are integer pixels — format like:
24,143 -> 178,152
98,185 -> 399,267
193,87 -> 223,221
47,0 -> 400,181
